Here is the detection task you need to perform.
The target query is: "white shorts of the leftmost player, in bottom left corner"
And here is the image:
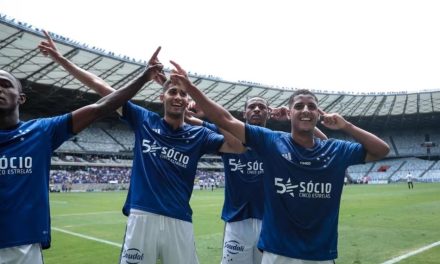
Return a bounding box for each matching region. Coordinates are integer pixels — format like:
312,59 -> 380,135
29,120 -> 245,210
0,243 -> 43,264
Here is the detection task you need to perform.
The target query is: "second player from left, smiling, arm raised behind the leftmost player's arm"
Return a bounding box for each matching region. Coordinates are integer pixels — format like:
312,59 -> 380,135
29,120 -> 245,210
39,31 -> 245,264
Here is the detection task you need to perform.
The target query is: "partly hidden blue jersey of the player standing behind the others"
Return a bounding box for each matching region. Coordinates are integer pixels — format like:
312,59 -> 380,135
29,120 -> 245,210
203,122 -> 264,222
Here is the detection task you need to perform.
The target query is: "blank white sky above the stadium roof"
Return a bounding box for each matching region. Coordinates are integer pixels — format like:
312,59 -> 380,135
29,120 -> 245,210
0,0 -> 440,92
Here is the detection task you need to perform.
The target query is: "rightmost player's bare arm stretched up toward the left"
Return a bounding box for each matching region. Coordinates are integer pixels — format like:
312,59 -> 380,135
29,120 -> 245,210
171,61 -> 245,143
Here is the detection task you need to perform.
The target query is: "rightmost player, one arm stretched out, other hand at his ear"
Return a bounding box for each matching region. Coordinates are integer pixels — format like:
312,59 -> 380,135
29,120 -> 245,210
171,62 -> 389,264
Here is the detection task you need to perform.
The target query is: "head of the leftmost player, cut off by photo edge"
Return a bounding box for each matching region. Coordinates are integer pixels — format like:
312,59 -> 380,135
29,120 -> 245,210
0,71 -> 24,110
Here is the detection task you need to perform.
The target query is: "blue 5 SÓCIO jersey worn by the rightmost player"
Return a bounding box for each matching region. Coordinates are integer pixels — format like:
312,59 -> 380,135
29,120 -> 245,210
246,125 -> 366,260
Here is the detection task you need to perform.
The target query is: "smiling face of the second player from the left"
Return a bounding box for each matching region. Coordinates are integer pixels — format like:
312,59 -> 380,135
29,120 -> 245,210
161,87 -> 188,118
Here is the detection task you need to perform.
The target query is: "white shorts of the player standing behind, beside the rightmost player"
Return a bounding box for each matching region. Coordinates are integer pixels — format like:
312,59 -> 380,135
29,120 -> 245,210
221,218 -> 262,264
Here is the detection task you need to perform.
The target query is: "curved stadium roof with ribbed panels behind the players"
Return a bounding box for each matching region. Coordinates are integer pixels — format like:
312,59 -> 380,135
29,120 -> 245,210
0,16 -> 440,129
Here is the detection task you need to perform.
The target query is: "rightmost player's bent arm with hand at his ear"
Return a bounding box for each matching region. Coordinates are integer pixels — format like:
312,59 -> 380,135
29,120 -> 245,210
320,110 -> 390,162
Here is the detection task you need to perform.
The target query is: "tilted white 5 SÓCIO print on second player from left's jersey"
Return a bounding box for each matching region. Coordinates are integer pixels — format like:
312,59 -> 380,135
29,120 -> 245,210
142,139 -> 189,168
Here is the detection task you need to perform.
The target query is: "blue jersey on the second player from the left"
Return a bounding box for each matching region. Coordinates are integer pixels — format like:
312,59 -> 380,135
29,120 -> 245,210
123,102 -> 223,222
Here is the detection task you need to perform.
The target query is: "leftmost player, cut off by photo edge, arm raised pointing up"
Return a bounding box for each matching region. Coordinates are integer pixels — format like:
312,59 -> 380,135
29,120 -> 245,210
0,40 -> 163,264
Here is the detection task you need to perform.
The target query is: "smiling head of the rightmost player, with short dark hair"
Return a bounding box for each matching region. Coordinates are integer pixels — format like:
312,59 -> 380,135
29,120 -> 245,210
290,94 -> 319,132
